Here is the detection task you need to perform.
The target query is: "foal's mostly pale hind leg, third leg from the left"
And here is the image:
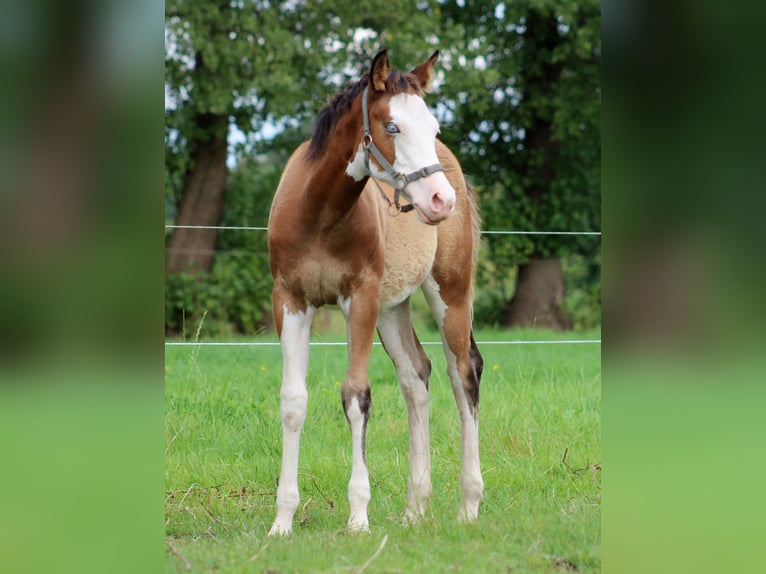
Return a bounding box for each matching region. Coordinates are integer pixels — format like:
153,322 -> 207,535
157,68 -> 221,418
378,301 -> 431,523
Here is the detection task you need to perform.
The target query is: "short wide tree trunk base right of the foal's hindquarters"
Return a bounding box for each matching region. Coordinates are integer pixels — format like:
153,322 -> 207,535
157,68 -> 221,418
505,257 -> 572,331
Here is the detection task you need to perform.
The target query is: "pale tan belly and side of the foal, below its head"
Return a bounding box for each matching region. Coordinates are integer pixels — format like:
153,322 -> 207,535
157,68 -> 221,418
380,213 -> 438,309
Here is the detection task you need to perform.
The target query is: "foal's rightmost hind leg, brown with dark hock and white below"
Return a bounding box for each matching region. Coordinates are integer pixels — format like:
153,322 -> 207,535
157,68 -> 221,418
424,278 -> 484,522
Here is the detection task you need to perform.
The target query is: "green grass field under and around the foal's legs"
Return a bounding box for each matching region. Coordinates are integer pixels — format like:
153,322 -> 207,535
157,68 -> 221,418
165,330 -> 601,573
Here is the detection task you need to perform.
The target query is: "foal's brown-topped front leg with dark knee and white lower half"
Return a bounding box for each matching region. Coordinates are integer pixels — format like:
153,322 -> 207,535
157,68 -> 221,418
338,292 -> 378,532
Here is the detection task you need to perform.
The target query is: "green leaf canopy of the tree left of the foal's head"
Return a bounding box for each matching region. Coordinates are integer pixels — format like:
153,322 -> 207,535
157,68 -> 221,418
165,0 -> 326,206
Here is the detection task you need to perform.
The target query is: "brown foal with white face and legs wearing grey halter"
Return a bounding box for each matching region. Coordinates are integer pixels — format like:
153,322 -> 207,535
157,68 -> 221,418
268,50 -> 484,535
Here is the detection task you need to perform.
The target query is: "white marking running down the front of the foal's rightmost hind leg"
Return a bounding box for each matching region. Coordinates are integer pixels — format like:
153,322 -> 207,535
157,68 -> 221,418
423,282 -> 484,522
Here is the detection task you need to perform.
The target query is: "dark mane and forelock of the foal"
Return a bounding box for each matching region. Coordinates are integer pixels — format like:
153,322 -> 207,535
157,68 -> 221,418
308,70 -> 423,160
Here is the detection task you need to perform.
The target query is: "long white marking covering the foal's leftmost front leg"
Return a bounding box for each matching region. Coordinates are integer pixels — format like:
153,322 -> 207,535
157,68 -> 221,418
269,306 -> 315,536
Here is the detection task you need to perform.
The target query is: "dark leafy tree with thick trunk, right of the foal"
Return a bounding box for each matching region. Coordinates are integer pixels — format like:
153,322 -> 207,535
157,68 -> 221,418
438,0 -> 600,329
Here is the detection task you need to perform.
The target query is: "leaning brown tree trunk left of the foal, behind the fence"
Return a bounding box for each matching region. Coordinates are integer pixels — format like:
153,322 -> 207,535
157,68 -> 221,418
165,113 -> 229,275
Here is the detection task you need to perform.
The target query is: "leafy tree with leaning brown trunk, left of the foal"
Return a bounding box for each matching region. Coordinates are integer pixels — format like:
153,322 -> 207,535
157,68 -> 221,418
165,0 -> 332,274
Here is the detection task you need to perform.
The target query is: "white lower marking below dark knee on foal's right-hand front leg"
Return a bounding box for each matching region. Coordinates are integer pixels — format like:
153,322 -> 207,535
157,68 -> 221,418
346,397 -> 370,532
